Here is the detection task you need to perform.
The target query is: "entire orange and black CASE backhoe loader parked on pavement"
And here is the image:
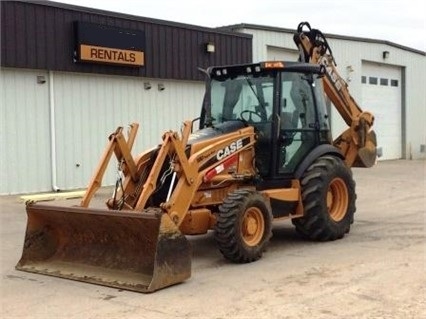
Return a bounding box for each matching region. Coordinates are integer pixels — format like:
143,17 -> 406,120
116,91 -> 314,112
16,22 -> 376,292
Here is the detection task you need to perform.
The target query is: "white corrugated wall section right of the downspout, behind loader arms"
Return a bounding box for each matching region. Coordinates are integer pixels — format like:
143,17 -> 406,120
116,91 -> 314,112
54,73 -> 204,189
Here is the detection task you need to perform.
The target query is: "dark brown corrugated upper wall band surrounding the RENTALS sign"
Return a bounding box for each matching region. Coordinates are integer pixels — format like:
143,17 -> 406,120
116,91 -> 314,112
0,1 -> 252,80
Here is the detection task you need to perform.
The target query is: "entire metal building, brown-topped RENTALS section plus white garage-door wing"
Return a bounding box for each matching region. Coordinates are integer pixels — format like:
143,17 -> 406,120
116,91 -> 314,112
0,1 -> 426,194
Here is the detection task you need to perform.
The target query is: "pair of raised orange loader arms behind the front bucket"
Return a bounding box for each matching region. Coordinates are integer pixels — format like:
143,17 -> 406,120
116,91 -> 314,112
80,121 -> 194,211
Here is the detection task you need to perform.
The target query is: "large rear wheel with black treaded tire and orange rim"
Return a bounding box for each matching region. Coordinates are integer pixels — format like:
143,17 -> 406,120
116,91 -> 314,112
292,156 -> 356,241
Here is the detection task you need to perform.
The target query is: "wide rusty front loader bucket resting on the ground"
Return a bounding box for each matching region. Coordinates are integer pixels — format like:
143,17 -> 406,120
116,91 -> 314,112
16,204 -> 191,292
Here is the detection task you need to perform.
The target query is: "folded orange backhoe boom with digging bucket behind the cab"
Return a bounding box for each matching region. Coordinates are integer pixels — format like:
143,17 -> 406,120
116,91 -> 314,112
294,22 -> 377,167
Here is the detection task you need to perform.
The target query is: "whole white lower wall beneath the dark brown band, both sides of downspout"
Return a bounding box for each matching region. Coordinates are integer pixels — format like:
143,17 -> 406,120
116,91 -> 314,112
0,68 -> 204,194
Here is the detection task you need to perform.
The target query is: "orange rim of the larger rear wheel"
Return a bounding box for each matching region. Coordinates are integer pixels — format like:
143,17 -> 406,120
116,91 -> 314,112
327,178 -> 349,222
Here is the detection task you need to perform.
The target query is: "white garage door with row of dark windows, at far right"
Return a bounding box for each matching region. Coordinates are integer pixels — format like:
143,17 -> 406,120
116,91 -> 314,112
361,62 -> 402,159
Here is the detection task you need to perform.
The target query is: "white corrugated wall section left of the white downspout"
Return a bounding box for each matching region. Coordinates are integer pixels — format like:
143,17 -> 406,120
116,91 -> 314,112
0,69 -> 51,194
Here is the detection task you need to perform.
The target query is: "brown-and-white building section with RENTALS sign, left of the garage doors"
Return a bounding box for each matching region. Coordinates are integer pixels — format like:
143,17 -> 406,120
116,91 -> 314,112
0,1 -> 252,194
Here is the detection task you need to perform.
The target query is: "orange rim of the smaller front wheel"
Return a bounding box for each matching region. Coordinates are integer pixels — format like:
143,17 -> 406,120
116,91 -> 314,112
241,207 -> 265,246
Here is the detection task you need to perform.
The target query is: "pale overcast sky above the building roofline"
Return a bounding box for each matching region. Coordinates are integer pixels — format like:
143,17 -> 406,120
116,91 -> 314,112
56,0 -> 426,51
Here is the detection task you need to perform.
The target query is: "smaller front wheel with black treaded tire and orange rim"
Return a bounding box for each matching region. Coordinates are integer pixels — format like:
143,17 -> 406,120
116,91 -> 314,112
215,190 -> 272,263
